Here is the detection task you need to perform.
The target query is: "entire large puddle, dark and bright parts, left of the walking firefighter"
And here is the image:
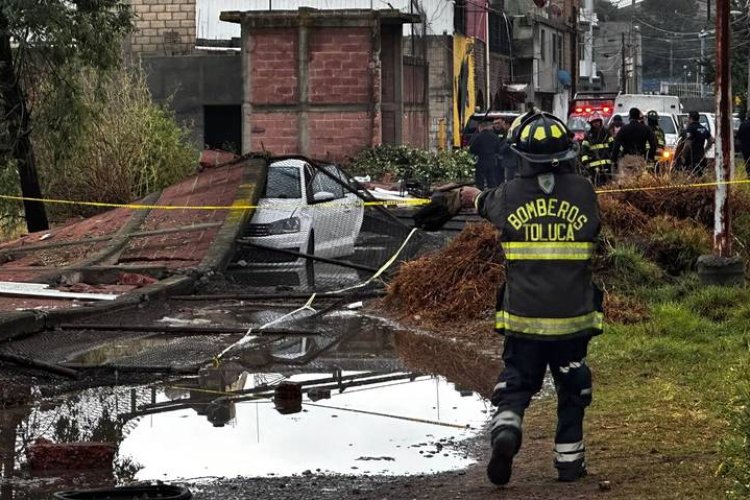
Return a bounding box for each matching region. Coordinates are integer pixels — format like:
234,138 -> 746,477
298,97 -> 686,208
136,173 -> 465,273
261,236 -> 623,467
0,315 -> 506,500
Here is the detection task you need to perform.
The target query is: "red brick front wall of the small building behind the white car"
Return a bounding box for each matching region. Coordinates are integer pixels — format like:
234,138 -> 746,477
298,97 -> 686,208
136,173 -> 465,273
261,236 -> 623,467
243,18 -> 381,161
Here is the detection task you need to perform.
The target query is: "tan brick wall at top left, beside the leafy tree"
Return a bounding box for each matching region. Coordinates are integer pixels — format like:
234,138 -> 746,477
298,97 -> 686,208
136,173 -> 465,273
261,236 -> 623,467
128,0 -> 195,54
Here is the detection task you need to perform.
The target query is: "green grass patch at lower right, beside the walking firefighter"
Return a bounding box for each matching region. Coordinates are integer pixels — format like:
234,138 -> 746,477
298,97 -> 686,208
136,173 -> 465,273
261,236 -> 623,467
587,275 -> 750,498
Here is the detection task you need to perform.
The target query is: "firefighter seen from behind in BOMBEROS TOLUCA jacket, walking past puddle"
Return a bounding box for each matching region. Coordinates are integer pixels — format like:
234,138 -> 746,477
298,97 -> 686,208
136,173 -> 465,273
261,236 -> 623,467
475,113 -> 603,485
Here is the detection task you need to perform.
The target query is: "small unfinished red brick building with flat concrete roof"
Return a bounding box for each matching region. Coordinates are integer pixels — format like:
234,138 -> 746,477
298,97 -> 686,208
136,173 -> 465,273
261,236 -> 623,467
221,9 -> 427,161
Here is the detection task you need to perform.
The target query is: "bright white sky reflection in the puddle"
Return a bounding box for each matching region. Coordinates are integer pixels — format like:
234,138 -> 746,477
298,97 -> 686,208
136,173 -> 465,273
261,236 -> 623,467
119,372 -> 488,480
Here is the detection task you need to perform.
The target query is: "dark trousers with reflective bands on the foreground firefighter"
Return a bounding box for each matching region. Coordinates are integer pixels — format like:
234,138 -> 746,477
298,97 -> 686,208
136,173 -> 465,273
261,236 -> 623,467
491,337 -> 591,465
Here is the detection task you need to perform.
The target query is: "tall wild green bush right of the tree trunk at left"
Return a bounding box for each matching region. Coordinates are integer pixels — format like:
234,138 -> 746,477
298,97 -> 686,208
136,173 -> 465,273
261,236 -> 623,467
32,69 -> 199,220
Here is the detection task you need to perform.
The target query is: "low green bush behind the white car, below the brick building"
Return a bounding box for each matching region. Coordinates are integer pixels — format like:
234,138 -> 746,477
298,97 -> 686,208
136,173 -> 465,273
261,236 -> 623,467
349,144 -> 474,183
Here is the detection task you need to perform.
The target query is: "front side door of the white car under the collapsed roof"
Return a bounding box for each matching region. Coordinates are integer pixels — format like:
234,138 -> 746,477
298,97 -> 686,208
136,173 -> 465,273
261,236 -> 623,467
310,167 -> 347,257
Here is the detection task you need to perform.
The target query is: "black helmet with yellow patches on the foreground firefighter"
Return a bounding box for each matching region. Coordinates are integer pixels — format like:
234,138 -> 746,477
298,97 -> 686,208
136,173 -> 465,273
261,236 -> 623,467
512,113 -> 578,164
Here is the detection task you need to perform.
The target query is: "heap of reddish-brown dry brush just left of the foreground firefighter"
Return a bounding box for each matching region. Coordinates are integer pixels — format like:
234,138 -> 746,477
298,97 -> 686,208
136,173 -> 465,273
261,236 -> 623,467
386,222 -> 503,321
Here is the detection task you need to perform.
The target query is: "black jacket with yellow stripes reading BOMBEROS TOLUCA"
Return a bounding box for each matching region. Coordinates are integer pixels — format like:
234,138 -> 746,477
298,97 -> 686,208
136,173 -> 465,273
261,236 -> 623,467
477,173 -> 604,340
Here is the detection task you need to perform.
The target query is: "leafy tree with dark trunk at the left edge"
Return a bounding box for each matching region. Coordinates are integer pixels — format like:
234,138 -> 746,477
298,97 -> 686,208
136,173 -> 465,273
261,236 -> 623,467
0,0 -> 132,231
